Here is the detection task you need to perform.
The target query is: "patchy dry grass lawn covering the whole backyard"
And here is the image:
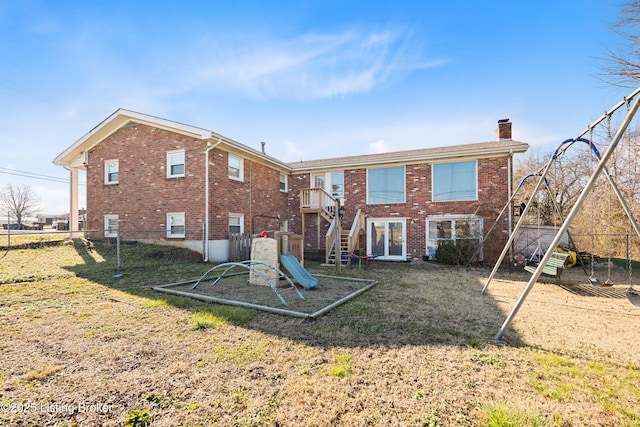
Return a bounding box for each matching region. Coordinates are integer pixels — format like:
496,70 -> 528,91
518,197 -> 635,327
0,241 -> 640,426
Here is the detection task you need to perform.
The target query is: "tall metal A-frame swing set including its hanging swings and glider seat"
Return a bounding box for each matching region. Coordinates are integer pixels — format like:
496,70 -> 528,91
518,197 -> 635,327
472,87 -> 640,340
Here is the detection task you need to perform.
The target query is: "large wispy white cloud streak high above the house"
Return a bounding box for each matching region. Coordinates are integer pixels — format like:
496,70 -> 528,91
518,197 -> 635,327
192,30 -> 445,99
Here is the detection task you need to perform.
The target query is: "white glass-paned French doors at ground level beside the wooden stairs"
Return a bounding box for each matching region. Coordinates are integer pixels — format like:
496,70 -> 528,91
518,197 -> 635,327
367,218 -> 407,261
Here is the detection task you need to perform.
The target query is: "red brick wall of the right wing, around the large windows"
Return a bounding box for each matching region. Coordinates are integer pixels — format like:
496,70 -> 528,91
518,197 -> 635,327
289,157 -> 511,260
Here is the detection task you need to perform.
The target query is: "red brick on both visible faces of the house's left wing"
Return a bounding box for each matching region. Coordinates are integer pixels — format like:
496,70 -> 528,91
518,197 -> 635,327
87,125 -> 287,240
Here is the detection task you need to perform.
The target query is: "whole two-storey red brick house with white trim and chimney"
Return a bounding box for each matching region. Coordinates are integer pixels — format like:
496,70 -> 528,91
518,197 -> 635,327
54,109 -> 528,262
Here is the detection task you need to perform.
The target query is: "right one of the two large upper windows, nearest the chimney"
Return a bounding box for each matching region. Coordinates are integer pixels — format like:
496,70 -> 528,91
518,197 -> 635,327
432,160 -> 478,202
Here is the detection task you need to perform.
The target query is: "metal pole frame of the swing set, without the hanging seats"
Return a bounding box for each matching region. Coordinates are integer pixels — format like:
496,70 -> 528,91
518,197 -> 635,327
482,87 -> 640,340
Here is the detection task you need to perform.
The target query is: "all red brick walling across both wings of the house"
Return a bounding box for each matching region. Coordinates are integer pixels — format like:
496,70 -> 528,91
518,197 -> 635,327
87,125 -> 511,260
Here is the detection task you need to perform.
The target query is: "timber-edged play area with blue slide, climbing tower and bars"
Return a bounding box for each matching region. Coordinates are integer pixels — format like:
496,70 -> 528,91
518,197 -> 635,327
152,231 -> 376,319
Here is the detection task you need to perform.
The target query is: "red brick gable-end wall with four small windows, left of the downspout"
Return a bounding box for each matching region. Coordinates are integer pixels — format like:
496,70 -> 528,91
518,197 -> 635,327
87,125 -> 205,239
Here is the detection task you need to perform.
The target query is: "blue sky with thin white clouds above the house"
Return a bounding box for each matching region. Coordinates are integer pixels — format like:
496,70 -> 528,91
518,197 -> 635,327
0,0 -> 630,213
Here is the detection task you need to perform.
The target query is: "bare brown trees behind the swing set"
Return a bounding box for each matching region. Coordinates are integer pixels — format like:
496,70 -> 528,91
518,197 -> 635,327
514,127 -> 640,258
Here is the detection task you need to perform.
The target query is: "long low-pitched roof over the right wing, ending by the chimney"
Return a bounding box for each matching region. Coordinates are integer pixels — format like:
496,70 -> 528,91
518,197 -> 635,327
289,140 -> 529,172
